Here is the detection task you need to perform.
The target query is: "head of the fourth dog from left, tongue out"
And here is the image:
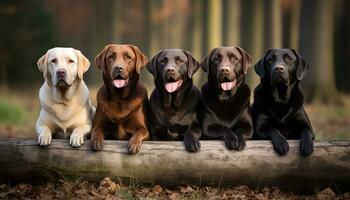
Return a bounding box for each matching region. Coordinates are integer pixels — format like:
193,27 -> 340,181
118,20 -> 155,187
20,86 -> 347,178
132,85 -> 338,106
200,47 -> 252,91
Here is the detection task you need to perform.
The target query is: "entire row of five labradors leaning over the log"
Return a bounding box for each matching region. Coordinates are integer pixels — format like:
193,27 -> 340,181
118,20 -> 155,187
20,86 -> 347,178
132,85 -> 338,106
36,44 -> 314,156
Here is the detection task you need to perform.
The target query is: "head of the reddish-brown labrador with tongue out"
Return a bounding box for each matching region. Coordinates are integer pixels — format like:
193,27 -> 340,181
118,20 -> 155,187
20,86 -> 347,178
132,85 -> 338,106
95,44 -> 148,88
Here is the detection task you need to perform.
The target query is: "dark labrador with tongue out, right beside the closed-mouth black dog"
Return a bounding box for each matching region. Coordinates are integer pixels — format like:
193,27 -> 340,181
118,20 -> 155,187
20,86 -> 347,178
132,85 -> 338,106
199,47 -> 253,150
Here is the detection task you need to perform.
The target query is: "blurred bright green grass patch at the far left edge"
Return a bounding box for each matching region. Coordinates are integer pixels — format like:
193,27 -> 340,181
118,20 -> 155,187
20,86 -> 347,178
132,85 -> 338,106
0,99 -> 26,125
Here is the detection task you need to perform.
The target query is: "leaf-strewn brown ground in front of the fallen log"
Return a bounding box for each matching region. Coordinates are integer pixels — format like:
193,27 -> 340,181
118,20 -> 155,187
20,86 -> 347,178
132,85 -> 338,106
0,178 -> 350,200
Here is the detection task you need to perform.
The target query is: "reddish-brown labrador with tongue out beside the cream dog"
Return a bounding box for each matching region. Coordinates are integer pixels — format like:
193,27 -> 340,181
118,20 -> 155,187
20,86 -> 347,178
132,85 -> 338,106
91,44 -> 149,154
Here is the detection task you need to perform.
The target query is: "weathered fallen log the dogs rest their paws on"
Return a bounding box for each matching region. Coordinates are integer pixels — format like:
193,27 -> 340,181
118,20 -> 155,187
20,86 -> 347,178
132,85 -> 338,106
0,139 -> 350,192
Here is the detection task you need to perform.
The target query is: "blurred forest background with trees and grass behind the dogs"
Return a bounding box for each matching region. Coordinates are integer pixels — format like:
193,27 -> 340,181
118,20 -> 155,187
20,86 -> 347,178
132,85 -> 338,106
0,0 -> 350,140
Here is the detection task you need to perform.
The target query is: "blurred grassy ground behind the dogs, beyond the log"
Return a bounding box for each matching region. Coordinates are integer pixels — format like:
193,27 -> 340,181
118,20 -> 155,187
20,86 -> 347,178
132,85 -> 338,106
0,86 -> 350,140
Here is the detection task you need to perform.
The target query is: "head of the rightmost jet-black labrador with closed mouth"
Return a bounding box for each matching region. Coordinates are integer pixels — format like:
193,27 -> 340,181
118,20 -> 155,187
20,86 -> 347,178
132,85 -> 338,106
254,49 -> 309,87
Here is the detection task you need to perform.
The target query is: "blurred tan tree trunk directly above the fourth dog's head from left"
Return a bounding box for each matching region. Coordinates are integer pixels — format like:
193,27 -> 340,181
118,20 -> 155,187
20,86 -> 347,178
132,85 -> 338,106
223,0 -> 241,46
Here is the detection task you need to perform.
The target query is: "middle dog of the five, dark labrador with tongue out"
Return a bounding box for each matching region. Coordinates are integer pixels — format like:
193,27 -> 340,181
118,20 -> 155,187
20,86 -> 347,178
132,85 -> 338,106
146,49 -> 202,152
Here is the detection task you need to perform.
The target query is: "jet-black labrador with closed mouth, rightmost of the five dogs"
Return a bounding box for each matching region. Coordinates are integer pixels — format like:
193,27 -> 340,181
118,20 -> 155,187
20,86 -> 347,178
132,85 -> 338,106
252,49 -> 314,156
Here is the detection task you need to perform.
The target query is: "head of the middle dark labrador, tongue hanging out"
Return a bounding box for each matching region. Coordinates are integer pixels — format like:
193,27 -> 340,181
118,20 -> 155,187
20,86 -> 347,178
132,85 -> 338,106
146,49 -> 199,93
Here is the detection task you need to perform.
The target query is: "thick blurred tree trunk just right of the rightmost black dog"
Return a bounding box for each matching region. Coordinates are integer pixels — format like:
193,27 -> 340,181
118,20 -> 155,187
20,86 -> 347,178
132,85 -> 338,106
300,0 -> 339,103
